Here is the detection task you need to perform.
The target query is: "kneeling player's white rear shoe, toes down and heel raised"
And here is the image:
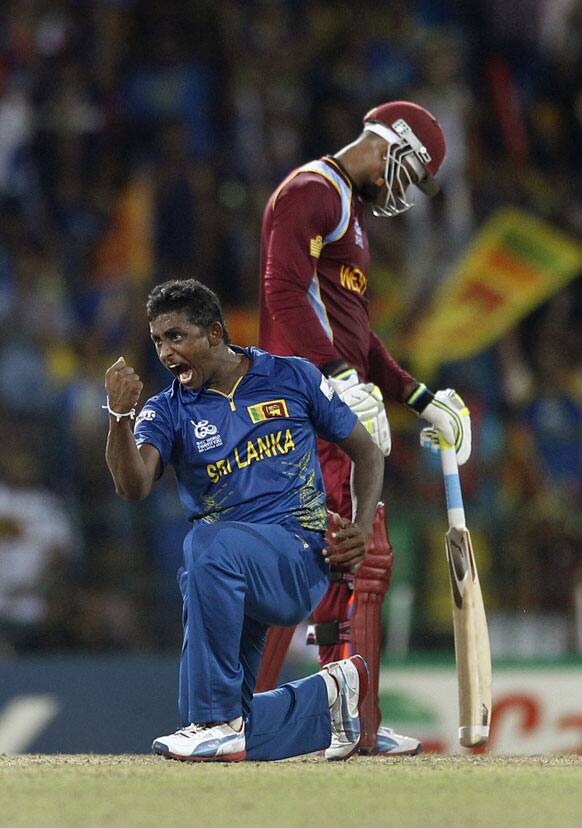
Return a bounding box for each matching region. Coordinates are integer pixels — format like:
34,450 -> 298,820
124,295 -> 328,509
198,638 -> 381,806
323,655 -> 368,761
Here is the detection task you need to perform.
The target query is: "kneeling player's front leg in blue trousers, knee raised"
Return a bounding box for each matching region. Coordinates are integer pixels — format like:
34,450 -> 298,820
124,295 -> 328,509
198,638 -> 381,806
180,522 -> 327,723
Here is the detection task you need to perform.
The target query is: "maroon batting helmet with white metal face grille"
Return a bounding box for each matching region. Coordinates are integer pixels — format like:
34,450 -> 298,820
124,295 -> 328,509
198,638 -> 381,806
364,101 -> 446,216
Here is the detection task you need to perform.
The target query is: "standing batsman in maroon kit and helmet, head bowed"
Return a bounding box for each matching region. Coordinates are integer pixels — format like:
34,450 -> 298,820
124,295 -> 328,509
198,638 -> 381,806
258,101 -> 471,755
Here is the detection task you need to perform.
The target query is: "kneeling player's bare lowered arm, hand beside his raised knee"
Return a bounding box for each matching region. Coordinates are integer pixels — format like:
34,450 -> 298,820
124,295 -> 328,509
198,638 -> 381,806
326,422 -> 384,568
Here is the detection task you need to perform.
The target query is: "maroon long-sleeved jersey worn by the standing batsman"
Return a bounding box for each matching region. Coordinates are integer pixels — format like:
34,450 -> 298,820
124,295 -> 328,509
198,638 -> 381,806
259,157 -> 413,401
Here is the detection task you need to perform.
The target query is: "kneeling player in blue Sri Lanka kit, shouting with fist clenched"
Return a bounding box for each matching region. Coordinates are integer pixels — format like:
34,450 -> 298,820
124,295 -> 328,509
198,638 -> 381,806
104,279 -> 384,762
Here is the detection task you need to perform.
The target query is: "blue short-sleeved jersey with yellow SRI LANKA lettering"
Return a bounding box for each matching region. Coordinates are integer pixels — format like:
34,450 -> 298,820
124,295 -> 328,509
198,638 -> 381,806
134,345 -> 357,532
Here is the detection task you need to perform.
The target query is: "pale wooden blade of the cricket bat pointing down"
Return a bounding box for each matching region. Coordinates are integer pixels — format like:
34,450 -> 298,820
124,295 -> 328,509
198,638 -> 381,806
445,527 -> 491,747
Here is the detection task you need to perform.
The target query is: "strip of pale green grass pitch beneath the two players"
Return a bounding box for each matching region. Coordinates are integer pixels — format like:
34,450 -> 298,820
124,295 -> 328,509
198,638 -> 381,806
0,754 -> 582,828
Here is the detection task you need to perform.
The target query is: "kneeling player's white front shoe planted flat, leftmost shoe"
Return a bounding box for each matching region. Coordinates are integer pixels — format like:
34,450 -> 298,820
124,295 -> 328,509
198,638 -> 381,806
152,722 -> 246,762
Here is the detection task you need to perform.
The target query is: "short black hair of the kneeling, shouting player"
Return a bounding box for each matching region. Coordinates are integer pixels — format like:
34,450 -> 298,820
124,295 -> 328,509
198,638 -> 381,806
146,279 -> 230,345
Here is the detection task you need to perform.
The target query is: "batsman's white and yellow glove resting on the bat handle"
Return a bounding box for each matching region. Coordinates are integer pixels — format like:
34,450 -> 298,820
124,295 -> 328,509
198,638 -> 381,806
406,385 -> 471,466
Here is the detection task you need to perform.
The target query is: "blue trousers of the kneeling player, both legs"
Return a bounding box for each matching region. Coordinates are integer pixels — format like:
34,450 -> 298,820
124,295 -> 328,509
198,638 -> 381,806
178,521 -> 331,760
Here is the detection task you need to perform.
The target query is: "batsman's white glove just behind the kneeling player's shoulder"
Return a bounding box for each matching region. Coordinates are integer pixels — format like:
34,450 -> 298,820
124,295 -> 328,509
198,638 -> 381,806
328,368 -> 392,457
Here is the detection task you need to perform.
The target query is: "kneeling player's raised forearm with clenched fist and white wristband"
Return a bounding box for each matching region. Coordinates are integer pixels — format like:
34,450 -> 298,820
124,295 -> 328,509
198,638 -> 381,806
105,357 -> 161,500
